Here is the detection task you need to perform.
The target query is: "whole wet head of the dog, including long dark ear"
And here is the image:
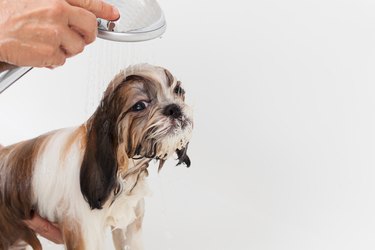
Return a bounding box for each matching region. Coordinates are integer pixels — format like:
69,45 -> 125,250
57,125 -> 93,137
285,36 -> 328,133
81,64 -> 193,208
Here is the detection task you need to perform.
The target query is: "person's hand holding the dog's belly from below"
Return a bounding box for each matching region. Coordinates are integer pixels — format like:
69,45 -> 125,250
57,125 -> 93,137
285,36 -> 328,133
24,211 -> 64,244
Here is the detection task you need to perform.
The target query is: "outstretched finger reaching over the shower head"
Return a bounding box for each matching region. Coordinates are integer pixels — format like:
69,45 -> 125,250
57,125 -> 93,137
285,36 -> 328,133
67,0 -> 120,20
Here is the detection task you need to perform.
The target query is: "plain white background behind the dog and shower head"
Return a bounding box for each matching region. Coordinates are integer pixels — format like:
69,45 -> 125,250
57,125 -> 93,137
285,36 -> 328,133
0,0 -> 375,250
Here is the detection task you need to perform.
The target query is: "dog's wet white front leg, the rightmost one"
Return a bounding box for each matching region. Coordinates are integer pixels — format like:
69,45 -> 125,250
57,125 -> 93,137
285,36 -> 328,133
112,199 -> 145,250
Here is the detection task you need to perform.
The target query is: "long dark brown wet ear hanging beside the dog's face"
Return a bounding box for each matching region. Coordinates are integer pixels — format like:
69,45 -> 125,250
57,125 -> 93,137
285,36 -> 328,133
80,79 -> 128,209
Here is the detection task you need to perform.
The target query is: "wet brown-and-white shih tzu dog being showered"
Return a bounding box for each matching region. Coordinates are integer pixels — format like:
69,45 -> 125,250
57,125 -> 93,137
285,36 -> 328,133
0,64 -> 193,250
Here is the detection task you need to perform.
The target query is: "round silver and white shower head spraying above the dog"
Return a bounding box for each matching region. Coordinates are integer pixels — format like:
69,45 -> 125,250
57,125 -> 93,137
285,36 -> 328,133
98,0 -> 166,42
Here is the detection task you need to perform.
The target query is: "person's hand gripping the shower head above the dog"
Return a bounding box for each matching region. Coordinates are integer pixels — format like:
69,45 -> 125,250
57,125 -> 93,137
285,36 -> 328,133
0,0 -> 119,68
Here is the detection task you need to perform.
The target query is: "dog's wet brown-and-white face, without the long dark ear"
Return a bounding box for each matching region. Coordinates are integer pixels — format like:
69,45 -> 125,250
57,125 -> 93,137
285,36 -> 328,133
117,68 -> 193,165
